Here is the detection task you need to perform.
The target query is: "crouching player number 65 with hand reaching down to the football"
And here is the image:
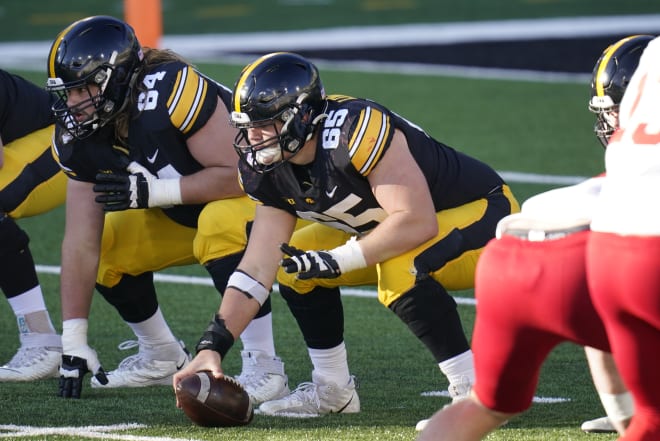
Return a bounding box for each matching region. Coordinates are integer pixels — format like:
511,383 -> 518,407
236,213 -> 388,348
174,52 -> 519,416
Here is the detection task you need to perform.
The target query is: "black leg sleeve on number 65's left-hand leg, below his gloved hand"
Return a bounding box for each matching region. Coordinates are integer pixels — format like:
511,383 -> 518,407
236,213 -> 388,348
280,285 -> 344,349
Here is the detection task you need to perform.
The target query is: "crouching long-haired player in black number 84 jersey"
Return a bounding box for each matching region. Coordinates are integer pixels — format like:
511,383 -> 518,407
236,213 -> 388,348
47,16 -> 289,401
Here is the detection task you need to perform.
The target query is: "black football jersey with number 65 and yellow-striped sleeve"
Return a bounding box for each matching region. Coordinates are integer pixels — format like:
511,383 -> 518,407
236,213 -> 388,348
239,95 -> 504,234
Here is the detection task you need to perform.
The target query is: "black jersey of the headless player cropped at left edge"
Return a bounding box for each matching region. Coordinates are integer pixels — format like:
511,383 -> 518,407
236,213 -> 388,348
0,69 -> 56,144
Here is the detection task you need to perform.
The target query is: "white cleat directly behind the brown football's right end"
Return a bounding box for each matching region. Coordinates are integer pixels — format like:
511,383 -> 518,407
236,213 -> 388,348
235,351 -> 290,407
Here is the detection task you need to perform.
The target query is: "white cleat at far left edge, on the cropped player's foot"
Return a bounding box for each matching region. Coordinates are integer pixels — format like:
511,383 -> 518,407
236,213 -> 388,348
0,346 -> 62,381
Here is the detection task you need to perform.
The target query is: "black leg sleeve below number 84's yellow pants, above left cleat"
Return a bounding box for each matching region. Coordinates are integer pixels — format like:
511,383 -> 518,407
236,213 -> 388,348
96,272 -> 158,323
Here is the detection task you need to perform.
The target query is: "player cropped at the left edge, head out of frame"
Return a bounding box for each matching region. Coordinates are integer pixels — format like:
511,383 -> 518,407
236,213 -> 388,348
0,70 -> 66,381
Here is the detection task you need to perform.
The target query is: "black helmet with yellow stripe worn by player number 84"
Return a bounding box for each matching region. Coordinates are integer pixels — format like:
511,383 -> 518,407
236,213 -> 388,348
46,16 -> 144,139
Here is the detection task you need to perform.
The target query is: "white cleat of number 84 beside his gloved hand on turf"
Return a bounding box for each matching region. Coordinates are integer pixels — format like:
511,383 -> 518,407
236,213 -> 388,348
92,341 -> 191,389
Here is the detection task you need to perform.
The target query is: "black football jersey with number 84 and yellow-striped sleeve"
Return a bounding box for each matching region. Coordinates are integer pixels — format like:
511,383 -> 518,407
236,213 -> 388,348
55,62 -> 231,227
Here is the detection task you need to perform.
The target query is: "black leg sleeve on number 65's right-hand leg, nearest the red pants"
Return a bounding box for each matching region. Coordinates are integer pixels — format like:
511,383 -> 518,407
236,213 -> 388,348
390,278 -> 470,363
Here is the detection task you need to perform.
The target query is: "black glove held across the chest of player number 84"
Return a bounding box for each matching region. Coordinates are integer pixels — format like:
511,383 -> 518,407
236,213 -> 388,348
94,173 -> 149,211
